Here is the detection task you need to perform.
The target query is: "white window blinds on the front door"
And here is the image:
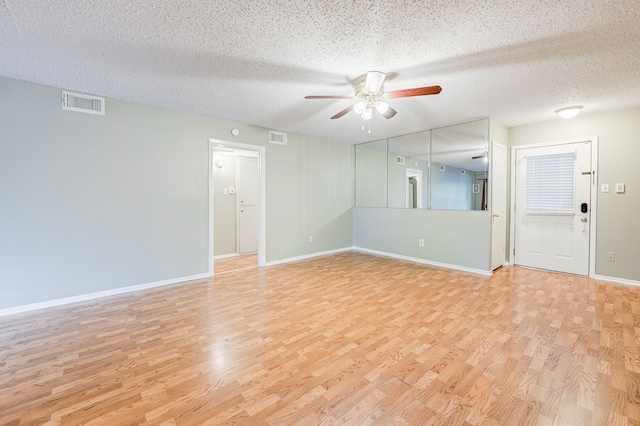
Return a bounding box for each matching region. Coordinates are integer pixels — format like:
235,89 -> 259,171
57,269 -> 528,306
526,152 -> 576,214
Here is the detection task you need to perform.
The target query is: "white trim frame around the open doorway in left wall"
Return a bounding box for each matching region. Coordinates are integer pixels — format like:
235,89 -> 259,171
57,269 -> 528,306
207,139 -> 267,277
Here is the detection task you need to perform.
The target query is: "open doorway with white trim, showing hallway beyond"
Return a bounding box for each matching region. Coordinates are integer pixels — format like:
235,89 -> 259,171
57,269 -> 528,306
209,139 -> 266,275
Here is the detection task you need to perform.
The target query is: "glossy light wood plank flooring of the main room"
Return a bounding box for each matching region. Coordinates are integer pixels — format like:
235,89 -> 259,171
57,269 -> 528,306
0,252 -> 640,426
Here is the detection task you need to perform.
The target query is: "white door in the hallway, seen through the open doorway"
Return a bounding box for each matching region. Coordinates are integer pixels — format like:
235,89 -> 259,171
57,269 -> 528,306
236,157 -> 260,254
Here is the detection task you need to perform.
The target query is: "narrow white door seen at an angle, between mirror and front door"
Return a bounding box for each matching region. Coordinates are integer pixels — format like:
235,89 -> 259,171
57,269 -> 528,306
489,141 -> 507,270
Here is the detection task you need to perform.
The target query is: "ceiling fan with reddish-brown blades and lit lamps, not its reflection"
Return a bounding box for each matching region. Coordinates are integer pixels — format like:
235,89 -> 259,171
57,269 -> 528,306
304,71 -> 442,133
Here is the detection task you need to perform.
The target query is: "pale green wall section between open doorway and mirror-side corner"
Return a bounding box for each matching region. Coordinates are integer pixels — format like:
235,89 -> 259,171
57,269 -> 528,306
266,135 -> 354,261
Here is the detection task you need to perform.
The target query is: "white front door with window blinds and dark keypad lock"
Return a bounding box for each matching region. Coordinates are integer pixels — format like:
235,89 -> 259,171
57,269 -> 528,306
514,142 -> 592,275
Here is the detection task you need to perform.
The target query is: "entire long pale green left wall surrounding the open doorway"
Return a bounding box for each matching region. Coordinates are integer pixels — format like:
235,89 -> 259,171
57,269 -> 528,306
0,77 -> 353,309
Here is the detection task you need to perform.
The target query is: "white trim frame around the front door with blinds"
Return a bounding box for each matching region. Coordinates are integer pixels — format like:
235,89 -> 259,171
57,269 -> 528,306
507,136 -> 599,278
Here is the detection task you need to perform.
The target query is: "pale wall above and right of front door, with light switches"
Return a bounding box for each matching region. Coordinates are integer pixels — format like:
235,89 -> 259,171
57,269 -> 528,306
509,108 -> 640,281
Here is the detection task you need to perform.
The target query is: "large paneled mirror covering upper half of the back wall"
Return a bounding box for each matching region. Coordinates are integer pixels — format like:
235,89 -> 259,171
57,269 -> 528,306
356,119 -> 489,210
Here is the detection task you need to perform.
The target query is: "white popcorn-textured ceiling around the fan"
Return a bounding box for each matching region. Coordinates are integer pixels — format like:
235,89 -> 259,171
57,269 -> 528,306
0,0 -> 640,143
